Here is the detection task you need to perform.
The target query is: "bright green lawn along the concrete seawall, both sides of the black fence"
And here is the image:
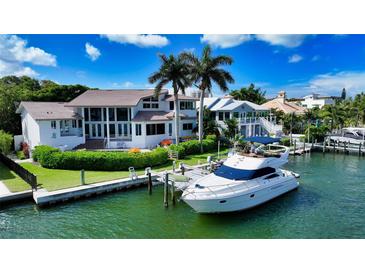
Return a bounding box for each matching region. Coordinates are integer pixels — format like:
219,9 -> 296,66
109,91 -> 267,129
0,149 -> 228,191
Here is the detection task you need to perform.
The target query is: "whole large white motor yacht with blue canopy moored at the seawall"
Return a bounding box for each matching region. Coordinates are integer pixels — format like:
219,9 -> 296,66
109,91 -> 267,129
182,137 -> 299,213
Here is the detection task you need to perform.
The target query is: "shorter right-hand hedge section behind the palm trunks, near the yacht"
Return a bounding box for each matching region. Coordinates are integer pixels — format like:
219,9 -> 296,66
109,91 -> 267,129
169,136 -> 217,158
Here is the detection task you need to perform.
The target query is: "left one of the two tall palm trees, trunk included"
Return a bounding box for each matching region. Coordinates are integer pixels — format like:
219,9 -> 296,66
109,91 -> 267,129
148,54 -> 191,144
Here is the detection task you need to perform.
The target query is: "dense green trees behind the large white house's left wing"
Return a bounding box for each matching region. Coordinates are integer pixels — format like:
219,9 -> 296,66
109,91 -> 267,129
0,76 -> 89,134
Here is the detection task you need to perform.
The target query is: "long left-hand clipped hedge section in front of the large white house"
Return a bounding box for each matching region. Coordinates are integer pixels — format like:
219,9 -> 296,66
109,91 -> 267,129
33,146 -> 168,171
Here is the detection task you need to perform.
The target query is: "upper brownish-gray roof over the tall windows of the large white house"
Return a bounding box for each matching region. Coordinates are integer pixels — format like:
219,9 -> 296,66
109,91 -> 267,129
66,89 -> 168,107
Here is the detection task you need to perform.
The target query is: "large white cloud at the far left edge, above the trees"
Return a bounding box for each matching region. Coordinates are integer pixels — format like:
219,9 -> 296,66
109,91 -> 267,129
0,35 -> 57,77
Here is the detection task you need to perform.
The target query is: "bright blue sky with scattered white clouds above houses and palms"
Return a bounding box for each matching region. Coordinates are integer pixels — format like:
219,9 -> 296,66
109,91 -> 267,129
0,35 -> 365,97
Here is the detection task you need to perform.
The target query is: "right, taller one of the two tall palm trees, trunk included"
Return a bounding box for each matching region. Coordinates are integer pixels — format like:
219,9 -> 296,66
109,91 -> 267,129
182,46 -> 234,152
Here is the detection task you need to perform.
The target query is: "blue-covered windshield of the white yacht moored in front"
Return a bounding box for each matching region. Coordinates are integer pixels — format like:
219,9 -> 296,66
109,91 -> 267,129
214,165 -> 275,180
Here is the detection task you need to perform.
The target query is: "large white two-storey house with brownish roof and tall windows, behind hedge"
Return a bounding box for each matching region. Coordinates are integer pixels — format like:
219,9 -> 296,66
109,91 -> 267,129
17,89 -> 197,149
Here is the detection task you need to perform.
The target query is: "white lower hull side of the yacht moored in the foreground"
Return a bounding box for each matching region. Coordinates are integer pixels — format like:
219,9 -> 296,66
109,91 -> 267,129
183,177 -> 299,213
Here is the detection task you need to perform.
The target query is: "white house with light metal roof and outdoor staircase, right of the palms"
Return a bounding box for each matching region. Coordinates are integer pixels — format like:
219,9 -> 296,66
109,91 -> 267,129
199,96 -> 282,137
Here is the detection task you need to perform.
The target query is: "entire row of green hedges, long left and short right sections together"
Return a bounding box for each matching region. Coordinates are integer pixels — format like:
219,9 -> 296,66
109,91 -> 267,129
33,136 -> 217,171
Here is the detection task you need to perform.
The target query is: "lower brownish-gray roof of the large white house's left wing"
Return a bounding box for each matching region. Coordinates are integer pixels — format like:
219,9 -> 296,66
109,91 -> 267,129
16,102 -> 82,120
